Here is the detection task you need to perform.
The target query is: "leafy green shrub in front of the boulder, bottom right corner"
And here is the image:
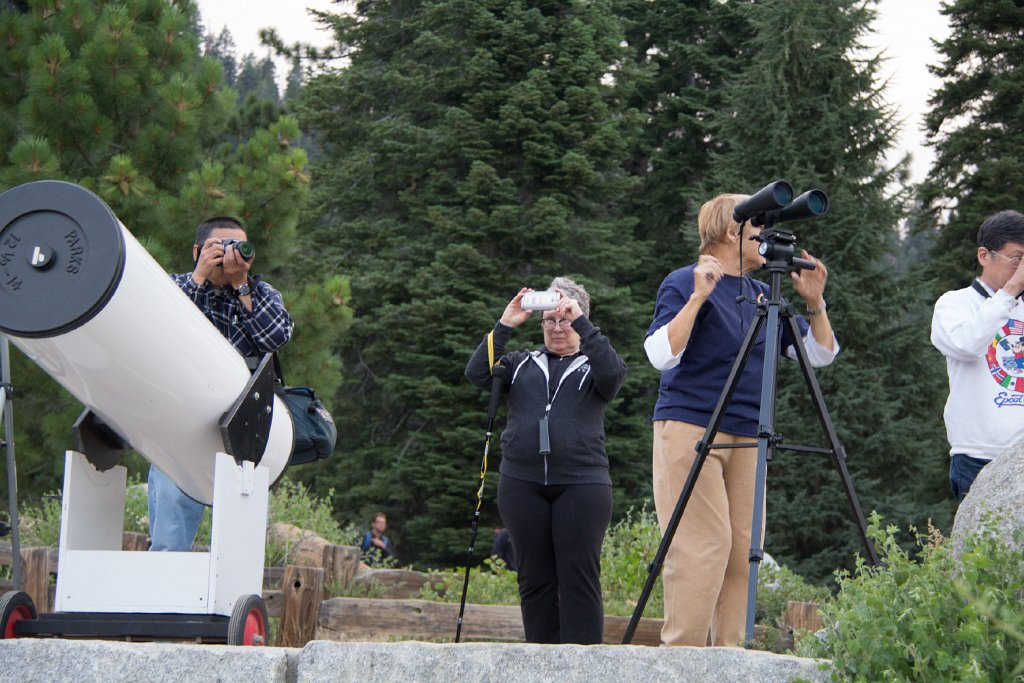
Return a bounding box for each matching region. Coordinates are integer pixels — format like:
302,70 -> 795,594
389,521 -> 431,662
799,514 -> 1024,683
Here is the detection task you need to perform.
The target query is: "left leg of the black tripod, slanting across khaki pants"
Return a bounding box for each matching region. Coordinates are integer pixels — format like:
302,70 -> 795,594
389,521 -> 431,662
623,316 -> 764,645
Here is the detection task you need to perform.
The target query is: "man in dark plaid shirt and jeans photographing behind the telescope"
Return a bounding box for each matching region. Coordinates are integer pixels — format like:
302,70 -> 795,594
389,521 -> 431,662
148,216 -> 294,552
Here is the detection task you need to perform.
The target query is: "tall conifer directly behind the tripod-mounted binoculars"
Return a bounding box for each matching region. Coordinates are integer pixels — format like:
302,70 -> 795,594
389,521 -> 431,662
706,0 -> 951,580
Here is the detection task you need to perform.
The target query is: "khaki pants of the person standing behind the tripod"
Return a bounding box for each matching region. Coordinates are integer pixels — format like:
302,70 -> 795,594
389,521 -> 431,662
653,420 -> 764,646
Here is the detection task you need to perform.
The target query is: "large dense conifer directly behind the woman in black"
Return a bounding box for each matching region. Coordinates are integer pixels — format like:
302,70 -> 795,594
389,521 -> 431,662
299,0 -> 649,564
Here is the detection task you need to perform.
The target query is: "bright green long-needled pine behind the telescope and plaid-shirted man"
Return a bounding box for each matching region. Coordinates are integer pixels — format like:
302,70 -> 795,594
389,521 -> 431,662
0,0 -> 347,494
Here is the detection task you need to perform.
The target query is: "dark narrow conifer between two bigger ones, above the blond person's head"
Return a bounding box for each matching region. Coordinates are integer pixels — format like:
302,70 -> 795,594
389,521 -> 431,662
615,0 -> 751,290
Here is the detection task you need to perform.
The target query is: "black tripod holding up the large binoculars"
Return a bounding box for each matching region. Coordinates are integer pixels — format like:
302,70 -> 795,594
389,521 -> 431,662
623,226 -> 879,644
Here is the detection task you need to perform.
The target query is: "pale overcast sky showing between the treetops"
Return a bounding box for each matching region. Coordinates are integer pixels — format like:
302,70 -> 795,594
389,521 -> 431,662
199,0 -> 949,181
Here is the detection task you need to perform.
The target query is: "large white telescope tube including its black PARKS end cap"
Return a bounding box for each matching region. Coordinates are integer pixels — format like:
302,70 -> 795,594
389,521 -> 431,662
0,180 -> 293,505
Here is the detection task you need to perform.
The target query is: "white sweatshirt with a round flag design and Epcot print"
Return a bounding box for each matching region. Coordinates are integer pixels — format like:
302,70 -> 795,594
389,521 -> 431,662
932,281 -> 1024,460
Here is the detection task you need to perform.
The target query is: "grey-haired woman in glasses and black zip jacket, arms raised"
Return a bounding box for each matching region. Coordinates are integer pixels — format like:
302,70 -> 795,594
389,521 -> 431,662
466,278 -> 626,644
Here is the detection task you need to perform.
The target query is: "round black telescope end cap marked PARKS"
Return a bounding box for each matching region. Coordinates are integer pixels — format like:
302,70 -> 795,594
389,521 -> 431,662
0,180 -> 125,338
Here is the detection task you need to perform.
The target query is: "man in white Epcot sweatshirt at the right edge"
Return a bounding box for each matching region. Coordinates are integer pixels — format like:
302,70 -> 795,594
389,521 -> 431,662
932,211 -> 1024,501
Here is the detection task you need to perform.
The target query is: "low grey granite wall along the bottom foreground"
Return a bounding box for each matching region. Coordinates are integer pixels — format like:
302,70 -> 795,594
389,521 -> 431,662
0,638 -> 827,683
